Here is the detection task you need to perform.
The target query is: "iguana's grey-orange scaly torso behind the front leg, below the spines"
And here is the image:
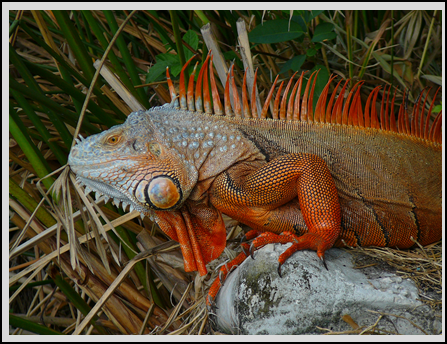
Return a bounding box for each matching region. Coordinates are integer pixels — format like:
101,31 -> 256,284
226,119 -> 442,248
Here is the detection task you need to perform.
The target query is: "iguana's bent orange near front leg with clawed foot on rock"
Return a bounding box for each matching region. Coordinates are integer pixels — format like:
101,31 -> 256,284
210,154 -> 341,263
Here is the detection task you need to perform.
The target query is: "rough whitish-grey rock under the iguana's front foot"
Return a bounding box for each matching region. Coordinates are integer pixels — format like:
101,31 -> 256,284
213,244 -> 442,335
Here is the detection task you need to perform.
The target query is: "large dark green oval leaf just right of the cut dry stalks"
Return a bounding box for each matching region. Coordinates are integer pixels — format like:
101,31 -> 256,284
248,19 -> 304,44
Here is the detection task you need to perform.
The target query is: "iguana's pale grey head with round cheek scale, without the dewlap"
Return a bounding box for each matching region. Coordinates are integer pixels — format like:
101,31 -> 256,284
68,107 -> 197,215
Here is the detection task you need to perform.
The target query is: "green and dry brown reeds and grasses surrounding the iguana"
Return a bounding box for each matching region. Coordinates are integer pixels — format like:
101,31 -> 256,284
8,10 -> 444,334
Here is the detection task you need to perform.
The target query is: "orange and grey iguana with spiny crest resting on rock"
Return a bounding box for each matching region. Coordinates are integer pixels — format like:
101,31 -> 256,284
68,52 -> 442,297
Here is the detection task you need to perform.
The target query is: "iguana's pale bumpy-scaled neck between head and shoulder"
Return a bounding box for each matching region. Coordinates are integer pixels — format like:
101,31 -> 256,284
147,105 -> 264,182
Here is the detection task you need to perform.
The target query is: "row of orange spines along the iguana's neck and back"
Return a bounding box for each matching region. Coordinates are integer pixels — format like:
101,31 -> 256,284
166,54 -> 442,144
